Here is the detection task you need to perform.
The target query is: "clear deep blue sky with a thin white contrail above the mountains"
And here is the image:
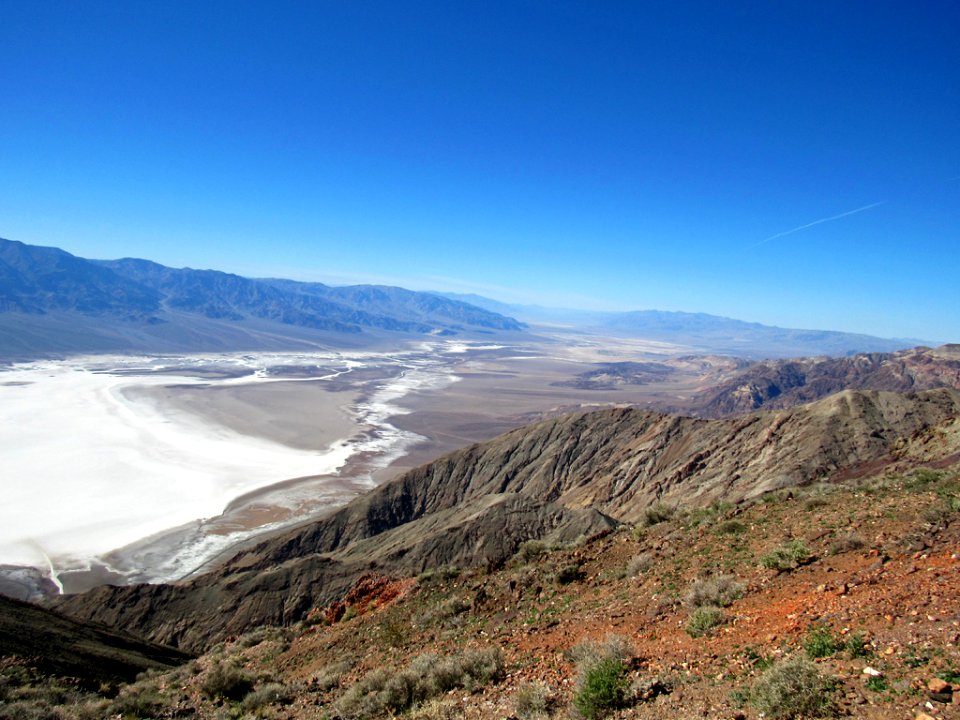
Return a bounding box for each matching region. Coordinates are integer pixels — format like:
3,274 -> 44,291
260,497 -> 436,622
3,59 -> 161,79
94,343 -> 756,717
0,0 -> 960,341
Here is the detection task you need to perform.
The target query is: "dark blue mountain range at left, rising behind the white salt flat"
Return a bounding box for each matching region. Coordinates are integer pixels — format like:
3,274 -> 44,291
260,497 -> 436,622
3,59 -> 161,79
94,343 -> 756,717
0,239 -> 523,358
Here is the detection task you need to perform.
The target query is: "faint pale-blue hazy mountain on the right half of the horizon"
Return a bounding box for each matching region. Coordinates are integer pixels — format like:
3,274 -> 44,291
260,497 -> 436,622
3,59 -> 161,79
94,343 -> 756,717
444,293 -> 938,358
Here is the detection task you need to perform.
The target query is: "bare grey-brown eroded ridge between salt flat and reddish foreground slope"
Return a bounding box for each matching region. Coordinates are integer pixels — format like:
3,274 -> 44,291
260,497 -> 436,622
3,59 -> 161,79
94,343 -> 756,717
61,389 -> 960,650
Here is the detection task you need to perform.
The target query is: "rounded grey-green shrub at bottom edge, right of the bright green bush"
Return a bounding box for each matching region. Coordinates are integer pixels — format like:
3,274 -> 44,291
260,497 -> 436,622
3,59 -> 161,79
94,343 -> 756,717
750,655 -> 834,718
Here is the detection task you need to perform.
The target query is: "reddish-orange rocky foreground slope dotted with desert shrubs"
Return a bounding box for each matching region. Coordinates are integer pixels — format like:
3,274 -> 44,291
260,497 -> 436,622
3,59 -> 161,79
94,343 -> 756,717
9,450 -> 960,720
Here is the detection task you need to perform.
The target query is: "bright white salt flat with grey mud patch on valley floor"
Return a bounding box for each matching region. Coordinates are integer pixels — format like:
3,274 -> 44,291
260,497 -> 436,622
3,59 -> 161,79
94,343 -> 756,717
0,347 -> 460,580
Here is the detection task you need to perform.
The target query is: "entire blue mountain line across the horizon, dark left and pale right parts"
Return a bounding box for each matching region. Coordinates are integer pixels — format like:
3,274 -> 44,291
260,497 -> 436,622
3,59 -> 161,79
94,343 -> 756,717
0,239 -> 923,360
